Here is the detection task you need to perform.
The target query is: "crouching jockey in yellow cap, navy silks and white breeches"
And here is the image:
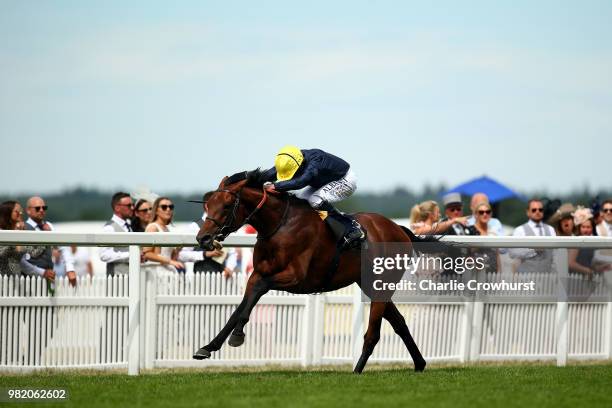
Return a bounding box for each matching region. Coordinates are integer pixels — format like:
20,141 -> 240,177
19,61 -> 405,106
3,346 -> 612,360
264,146 -> 365,248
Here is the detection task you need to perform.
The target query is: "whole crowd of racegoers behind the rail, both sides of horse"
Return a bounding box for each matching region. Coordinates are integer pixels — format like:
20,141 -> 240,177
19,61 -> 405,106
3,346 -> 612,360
0,192 -> 612,285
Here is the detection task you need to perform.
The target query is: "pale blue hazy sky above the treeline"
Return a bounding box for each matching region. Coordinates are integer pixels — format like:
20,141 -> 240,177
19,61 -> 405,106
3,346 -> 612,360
0,0 -> 612,194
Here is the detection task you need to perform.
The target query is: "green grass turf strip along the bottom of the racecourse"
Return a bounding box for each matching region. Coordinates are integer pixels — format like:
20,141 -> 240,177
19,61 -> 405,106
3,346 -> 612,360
0,364 -> 612,408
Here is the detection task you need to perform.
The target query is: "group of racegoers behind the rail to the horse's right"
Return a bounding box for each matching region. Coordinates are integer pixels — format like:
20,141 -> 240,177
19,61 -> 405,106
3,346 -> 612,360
410,193 -> 612,275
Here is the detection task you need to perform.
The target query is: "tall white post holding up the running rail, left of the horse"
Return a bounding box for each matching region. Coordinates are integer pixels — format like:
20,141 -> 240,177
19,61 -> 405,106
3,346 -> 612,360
127,245 -> 140,375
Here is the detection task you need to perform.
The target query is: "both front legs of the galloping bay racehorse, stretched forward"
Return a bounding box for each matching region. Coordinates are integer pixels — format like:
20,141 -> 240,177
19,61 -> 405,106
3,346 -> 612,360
193,273 -> 268,360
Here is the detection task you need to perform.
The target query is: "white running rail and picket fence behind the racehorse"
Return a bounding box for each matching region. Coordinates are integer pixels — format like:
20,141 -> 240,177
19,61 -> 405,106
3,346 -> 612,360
0,231 -> 612,375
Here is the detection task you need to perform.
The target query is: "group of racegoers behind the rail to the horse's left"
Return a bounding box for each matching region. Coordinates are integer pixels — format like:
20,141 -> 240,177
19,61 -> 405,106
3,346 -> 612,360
0,192 -> 244,285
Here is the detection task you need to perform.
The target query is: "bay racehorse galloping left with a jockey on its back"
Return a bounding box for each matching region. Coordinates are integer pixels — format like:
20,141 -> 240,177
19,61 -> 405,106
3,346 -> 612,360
193,169 -> 438,373
